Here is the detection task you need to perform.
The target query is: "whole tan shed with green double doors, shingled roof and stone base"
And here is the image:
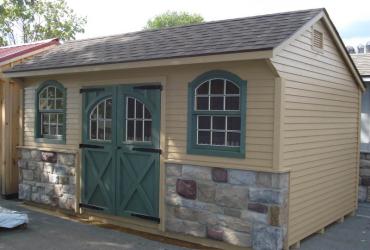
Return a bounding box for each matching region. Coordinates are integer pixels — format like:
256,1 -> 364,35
2,9 -> 364,249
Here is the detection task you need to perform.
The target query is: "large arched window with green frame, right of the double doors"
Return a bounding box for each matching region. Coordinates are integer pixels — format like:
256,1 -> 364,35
188,71 -> 246,157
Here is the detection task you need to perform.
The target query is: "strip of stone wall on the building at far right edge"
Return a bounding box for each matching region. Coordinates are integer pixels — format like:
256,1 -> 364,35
358,153 -> 370,202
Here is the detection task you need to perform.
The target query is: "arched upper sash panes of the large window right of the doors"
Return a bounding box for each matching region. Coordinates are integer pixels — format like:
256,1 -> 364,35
195,79 -> 240,111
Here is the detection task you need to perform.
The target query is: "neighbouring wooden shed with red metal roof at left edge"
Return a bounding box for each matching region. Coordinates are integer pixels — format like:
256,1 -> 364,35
0,39 -> 59,198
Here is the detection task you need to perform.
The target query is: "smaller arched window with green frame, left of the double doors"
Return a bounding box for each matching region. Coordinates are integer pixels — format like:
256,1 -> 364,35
35,81 -> 66,143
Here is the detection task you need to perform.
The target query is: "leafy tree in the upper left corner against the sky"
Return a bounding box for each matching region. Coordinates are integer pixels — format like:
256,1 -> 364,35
0,0 -> 86,45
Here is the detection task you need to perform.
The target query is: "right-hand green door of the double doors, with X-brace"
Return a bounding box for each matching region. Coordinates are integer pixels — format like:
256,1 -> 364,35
117,86 -> 160,217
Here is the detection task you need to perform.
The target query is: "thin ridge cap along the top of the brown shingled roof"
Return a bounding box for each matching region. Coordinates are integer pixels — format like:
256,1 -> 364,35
65,8 -> 325,43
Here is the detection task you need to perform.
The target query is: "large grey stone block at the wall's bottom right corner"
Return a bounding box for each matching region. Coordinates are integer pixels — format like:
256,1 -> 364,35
252,224 -> 284,250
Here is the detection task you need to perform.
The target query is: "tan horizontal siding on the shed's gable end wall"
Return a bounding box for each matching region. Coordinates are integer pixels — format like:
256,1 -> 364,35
273,22 -> 360,245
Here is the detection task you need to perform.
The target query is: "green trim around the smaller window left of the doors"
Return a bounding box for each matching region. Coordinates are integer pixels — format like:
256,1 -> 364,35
34,80 -> 67,144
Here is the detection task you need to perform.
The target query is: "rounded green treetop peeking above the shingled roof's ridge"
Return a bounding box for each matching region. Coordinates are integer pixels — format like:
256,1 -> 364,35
144,11 -> 204,29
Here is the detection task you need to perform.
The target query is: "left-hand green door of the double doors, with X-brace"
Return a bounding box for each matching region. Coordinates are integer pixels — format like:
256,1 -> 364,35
82,87 -> 116,213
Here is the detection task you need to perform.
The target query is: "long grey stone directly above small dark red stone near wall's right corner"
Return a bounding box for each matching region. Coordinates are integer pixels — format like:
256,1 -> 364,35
249,188 -> 287,204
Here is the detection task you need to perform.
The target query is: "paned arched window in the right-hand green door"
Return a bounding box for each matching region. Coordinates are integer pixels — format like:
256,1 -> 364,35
125,97 -> 152,142
